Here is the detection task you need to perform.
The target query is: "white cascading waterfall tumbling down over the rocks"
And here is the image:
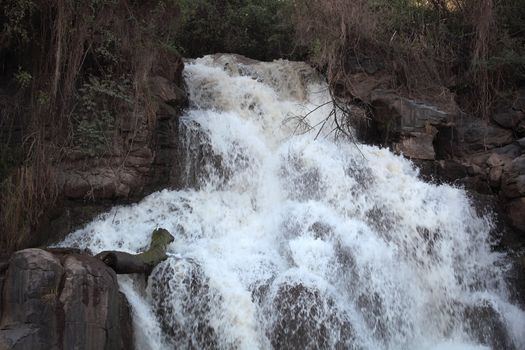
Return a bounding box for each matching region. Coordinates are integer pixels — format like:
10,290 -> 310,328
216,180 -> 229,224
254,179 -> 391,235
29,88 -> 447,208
59,55 -> 525,350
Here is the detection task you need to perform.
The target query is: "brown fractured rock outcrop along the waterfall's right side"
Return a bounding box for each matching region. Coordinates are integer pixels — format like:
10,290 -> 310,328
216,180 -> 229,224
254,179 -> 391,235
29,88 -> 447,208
346,71 -> 525,247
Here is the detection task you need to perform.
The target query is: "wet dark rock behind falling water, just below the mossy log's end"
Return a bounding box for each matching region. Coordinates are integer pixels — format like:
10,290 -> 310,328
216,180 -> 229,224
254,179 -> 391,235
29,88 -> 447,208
148,258 -> 220,349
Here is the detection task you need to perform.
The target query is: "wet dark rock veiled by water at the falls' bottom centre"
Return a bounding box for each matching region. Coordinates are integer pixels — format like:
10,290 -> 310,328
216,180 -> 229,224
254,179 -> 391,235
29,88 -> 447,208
265,283 -> 356,350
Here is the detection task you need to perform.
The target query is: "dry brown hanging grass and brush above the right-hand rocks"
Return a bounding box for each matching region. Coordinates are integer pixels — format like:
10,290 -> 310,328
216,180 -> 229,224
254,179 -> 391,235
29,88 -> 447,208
294,0 -> 512,118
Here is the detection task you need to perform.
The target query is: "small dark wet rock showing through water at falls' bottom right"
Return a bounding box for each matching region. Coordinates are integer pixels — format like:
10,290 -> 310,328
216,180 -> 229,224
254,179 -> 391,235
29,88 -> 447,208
463,302 -> 516,350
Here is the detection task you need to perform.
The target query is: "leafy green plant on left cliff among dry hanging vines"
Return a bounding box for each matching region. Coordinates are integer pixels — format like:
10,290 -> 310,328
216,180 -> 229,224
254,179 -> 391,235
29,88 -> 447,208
70,76 -> 133,157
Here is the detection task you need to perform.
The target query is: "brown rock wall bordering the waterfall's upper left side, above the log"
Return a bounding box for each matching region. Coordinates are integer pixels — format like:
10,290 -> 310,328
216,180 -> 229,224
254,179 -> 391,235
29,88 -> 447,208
41,56 -> 188,245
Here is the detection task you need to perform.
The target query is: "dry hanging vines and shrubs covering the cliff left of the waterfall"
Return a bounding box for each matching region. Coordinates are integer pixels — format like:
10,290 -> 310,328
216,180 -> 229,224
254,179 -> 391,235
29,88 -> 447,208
0,0 -> 182,251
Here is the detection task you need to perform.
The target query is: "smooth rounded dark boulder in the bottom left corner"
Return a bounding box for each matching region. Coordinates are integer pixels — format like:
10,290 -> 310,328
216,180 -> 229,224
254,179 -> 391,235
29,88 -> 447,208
0,249 -> 133,350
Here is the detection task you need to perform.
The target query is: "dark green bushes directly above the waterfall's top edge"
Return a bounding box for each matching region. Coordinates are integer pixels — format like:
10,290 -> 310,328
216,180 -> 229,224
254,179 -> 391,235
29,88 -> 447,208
176,0 -> 296,60
